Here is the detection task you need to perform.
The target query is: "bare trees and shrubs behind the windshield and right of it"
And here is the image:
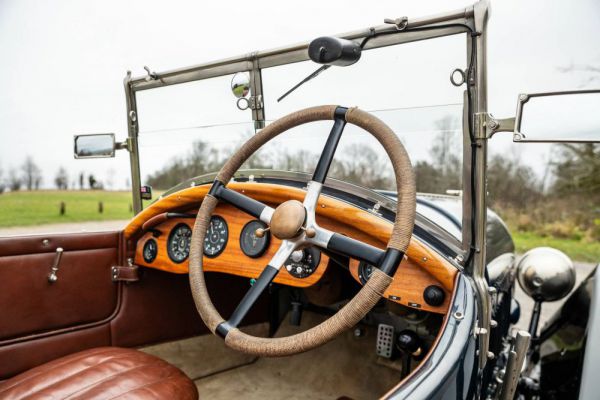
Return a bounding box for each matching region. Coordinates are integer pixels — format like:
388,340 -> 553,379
146,117 -> 600,240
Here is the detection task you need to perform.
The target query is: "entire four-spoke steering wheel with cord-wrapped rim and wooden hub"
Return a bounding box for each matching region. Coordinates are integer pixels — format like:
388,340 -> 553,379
189,106 -> 416,357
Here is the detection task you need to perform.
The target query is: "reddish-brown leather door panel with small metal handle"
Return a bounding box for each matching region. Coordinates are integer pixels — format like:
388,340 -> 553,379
0,232 -> 119,346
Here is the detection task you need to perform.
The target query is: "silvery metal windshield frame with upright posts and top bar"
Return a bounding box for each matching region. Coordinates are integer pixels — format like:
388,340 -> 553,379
123,0 -> 494,370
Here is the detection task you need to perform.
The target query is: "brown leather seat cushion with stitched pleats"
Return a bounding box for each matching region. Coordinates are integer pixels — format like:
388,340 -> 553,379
0,347 -> 198,400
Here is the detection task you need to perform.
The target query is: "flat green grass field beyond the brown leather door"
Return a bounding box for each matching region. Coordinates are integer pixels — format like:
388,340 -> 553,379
0,190 -> 133,227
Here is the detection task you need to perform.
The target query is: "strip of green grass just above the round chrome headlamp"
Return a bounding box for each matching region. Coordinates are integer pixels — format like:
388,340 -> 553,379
513,231 -> 600,263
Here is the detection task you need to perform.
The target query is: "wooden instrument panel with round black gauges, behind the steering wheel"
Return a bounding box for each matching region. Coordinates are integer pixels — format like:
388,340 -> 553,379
134,209 -> 329,287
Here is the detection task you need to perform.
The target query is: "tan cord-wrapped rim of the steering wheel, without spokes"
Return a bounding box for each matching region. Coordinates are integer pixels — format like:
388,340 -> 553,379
189,105 -> 416,357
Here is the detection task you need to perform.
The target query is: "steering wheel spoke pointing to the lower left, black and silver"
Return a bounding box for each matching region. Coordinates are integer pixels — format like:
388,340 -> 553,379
216,240 -> 296,337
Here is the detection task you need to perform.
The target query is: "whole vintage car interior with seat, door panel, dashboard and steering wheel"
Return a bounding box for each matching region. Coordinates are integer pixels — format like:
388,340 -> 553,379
0,106 -> 513,399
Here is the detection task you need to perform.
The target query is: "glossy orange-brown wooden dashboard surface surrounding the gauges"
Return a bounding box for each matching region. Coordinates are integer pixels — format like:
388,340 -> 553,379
129,182 -> 458,314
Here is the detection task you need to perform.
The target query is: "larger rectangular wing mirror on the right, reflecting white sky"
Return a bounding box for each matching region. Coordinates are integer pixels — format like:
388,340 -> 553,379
513,89 -> 600,143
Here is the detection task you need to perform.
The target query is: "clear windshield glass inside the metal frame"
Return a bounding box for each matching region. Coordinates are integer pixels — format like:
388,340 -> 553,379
138,35 -> 466,199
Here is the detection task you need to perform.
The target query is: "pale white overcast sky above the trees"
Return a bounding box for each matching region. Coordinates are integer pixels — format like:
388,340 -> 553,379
0,0 -> 600,191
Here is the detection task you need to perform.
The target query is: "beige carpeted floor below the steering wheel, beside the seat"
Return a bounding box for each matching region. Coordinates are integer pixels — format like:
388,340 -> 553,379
195,313 -> 400,400
